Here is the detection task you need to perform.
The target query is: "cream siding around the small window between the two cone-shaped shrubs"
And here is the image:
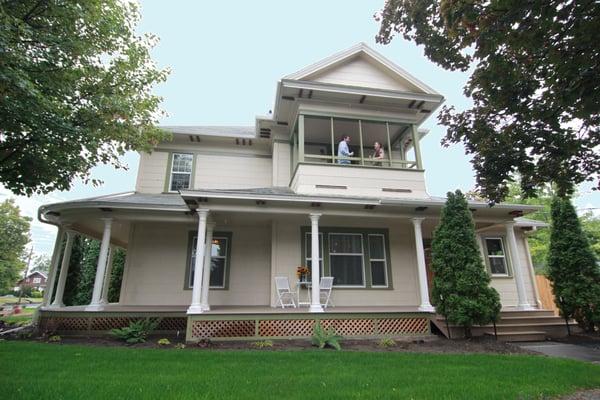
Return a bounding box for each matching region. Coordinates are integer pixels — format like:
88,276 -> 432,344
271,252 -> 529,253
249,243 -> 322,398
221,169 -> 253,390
482,229 -> 537,307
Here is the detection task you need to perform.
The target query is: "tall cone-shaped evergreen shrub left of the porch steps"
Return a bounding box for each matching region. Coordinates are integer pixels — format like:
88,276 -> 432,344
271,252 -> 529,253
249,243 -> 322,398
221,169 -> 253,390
432,190 -> 501,337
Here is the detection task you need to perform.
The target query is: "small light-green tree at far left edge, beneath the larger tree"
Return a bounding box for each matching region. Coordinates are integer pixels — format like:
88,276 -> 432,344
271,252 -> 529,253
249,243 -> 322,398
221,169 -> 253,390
0,199 -> 31,292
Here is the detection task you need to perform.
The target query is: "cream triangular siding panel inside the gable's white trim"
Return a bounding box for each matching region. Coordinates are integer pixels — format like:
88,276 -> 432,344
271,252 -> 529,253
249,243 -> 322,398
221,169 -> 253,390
306,57 -> 421,92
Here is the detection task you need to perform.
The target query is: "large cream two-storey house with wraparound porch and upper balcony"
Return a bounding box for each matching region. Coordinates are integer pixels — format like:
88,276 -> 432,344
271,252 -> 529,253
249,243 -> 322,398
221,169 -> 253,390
39,44 -> 564,341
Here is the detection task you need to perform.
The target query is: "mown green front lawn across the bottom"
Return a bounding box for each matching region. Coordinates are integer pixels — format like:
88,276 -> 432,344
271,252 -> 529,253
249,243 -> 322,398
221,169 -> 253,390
0,341 -> 600,400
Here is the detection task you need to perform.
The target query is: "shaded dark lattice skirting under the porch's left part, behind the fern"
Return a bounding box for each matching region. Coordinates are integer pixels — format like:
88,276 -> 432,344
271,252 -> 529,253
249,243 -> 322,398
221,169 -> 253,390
39,315 -> 187,334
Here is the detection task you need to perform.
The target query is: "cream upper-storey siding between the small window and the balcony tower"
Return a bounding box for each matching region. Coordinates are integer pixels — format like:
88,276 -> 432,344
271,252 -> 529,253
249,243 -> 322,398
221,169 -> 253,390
194,154 -> 273,189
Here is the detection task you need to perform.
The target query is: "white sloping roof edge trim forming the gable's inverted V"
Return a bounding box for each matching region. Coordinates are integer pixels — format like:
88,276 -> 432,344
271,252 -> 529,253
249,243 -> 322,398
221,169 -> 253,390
283,42 -> 439,95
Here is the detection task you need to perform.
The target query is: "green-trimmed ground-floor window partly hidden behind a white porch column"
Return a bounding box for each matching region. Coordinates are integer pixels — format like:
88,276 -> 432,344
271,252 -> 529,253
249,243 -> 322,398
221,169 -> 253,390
187,233 -> 231,289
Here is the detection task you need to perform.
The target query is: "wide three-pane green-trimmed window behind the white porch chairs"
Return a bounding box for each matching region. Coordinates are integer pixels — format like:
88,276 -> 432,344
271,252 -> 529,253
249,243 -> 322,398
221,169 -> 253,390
302,227 -> 391,289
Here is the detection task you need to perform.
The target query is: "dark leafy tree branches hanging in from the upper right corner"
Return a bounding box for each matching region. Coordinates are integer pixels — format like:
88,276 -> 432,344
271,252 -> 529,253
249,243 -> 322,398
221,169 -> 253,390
376,0 -> 600,202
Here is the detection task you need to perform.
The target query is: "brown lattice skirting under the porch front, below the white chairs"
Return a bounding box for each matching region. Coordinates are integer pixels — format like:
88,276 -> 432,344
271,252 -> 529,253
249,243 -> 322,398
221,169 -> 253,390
187,317 -> 430,341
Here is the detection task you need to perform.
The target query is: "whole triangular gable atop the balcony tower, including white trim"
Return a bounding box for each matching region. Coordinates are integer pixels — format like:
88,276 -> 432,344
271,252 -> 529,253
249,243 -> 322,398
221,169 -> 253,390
284,43 -> 438,94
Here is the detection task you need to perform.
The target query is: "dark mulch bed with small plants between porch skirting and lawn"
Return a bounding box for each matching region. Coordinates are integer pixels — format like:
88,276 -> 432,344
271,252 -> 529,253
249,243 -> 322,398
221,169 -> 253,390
4,336 -> 538,354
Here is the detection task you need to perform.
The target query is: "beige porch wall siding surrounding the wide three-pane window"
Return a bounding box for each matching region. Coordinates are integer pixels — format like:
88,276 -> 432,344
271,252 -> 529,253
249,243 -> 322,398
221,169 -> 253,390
271,216 -> 419,306
